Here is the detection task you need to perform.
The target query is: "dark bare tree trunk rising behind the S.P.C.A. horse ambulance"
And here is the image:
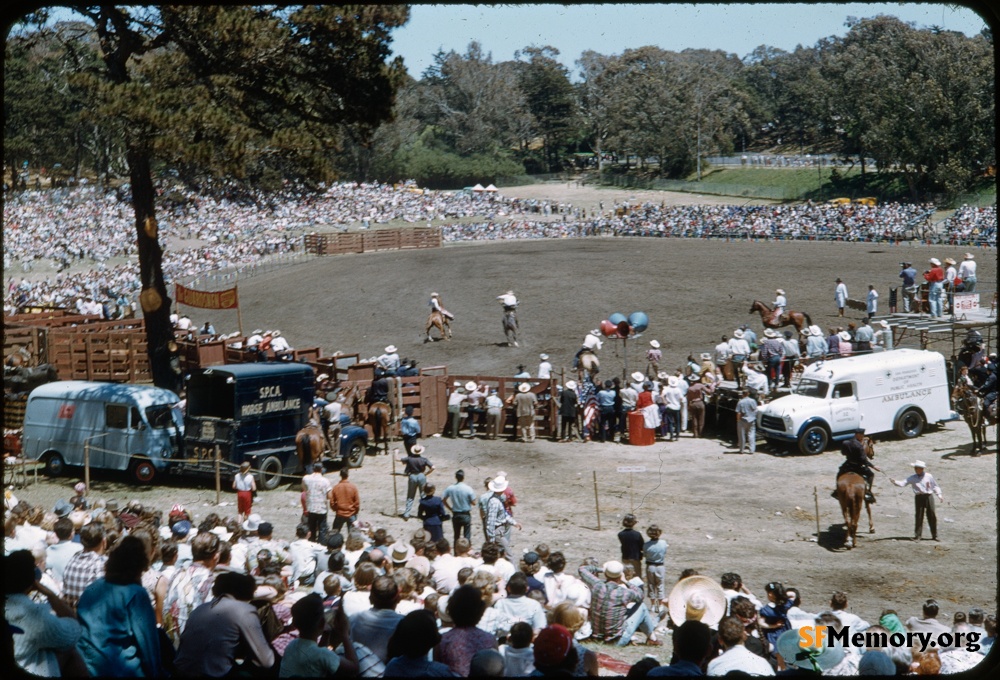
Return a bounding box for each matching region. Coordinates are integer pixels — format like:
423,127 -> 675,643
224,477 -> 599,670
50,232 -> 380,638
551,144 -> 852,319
127,147 -> 181,392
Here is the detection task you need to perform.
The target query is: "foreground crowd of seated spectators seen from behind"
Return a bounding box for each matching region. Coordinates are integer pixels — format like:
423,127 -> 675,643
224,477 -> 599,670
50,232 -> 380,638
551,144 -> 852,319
3,484 -> 997,677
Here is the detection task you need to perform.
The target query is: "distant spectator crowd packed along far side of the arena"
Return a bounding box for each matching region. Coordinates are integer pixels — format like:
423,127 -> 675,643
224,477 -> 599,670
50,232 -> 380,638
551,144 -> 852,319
3,181 -> 996,311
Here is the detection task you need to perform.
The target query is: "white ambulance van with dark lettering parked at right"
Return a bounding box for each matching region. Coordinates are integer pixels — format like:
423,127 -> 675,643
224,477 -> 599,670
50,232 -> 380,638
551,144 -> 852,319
757,349 -> 958,454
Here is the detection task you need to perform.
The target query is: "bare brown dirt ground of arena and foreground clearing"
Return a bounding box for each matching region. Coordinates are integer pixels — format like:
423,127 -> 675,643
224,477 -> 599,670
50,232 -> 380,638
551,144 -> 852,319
11,186 -> 997,662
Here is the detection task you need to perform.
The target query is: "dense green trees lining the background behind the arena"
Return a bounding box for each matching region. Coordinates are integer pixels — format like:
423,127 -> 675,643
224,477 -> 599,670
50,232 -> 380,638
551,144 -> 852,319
4,8 -> 996,200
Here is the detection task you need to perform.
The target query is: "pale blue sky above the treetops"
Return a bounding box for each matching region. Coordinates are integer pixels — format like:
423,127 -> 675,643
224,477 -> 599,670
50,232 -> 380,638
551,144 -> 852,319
393,3 -> 986,77
